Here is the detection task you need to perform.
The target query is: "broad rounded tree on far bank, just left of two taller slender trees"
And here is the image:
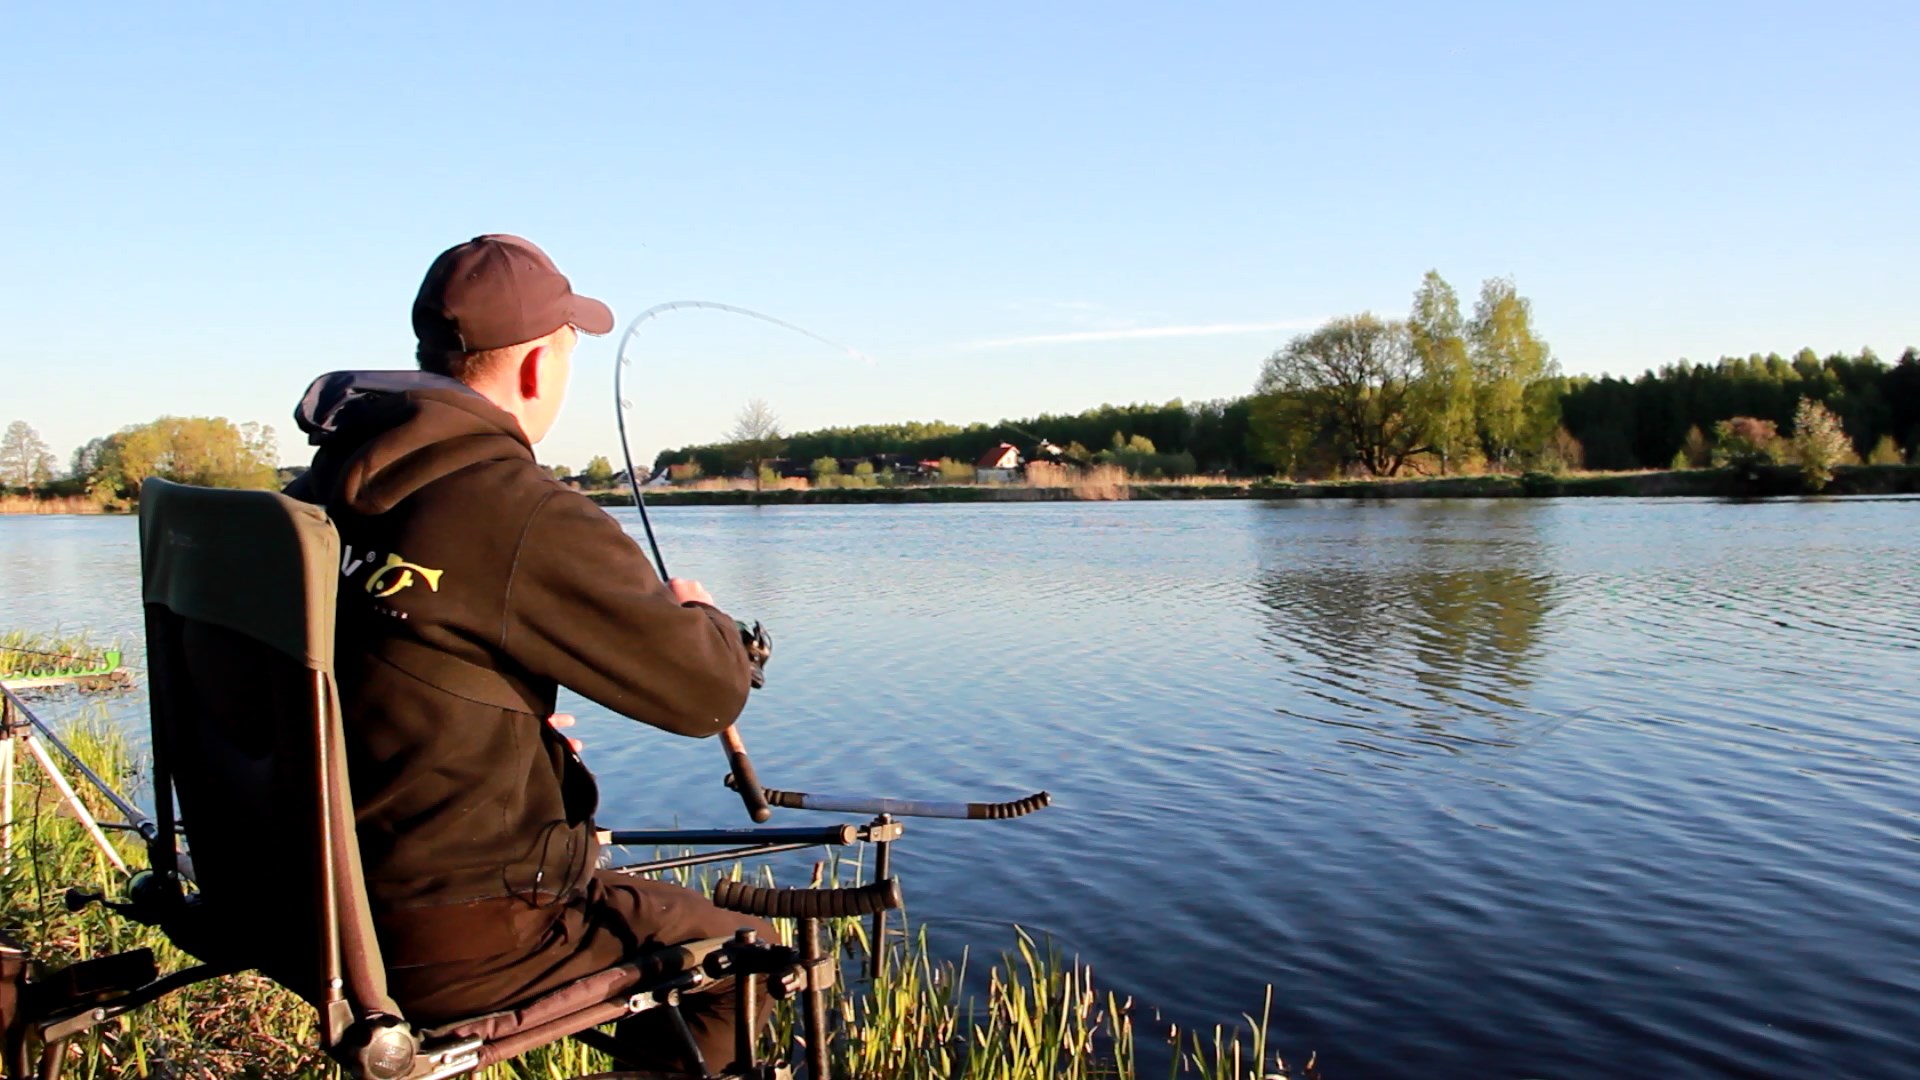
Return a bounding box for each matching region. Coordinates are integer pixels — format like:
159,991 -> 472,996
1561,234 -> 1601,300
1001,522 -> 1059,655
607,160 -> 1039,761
1256,313 -> 1427,477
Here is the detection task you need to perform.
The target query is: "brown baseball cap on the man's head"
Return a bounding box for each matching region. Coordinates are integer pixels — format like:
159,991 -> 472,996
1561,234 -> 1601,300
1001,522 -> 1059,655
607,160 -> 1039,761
413,233 -> 612,352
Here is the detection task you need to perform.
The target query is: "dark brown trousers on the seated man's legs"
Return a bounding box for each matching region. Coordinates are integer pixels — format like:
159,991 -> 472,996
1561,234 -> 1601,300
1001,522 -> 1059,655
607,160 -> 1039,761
388,871 -> 778,1072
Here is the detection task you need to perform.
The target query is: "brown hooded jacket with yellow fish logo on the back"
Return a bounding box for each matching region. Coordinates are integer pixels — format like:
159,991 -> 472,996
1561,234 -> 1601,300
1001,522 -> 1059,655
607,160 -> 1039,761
288,371 -> 751,967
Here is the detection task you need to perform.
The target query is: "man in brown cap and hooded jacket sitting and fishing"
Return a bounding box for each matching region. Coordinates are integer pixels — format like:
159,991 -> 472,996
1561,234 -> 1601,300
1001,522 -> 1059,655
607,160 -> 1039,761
288,234 -> 774,1070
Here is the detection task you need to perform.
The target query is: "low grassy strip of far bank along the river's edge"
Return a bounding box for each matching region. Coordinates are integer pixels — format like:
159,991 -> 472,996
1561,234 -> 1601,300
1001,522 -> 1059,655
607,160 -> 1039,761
591,465 -> 1920,505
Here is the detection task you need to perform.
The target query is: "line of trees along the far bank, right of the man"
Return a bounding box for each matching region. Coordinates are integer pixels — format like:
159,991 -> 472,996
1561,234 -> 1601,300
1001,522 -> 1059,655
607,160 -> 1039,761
655,271 -> 1920,479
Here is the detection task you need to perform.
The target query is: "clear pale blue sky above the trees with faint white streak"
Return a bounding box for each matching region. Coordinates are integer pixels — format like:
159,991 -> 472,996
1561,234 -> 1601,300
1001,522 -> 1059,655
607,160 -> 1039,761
0,2 -> 1920,467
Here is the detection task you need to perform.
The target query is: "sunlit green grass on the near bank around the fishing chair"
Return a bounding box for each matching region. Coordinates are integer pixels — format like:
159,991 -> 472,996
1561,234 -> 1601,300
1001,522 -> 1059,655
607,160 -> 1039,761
0,719 -> 1315,1080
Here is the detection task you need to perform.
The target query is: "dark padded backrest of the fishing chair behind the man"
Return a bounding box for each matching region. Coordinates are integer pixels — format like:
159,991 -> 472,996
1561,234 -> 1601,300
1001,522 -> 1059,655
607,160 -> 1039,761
140,480 -> 399,1045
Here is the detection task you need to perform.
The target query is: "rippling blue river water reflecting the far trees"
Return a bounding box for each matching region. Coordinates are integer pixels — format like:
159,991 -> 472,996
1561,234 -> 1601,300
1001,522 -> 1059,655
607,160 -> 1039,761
0,500 -> 1920,1080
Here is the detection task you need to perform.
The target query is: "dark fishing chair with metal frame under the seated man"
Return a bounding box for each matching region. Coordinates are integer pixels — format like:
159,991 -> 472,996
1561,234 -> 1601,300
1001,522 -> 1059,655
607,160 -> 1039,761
0,480 -> 900,1080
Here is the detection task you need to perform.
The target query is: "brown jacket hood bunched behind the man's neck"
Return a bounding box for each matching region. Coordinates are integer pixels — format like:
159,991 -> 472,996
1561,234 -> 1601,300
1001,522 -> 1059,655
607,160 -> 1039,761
290,371 -> 534,515
